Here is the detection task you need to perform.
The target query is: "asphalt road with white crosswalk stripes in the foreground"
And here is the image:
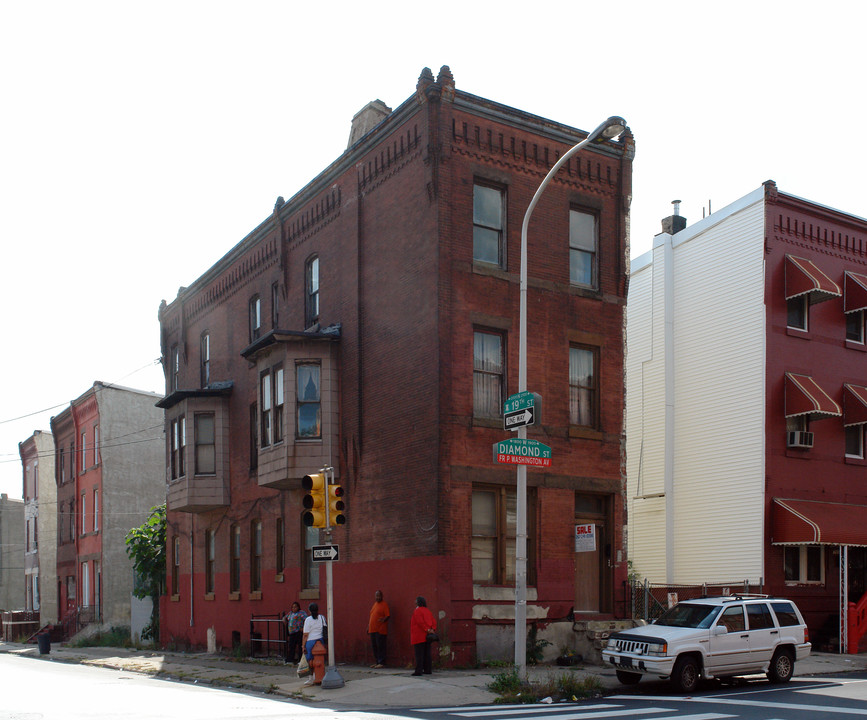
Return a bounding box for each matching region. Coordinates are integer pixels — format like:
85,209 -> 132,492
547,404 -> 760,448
0,655 -> 867,720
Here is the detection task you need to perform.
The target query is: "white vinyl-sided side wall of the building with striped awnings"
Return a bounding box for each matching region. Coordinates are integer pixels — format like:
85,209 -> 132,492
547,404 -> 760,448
626,188 -> 766,584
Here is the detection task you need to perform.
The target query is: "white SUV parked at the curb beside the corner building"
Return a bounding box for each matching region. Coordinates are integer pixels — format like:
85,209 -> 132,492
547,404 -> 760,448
602,595 -> 810,692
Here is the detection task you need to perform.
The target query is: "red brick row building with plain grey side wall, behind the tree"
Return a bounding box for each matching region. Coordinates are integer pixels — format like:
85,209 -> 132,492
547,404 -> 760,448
50,382 -> 165,635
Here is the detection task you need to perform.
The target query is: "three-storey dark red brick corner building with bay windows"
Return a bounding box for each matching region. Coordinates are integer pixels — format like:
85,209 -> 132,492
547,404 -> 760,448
160,67 -> 634,663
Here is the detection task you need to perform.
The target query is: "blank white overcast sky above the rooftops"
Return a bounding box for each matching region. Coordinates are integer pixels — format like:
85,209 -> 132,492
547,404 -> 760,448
0,0 -> 867,498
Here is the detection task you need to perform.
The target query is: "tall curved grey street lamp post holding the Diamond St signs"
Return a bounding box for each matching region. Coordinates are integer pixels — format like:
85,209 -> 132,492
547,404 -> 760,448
515,116 -> 626,677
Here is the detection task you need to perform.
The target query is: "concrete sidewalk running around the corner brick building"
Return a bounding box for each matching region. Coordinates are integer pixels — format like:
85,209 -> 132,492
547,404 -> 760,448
0,642 -> 867,709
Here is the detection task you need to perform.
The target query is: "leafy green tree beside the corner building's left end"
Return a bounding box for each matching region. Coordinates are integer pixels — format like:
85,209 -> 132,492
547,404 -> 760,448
126,503 -> 166,640
